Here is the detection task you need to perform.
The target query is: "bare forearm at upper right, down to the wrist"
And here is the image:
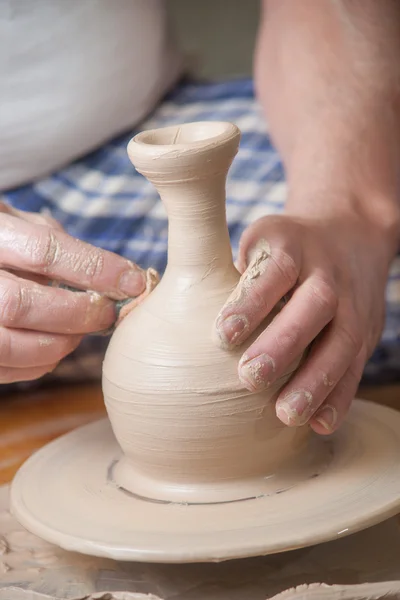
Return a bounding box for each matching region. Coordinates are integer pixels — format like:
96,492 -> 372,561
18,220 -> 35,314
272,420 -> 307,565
255,0 -> 400,252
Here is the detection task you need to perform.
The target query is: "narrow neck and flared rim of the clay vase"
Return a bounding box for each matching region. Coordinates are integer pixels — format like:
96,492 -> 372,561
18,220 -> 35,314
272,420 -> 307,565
128,122 -> 240,270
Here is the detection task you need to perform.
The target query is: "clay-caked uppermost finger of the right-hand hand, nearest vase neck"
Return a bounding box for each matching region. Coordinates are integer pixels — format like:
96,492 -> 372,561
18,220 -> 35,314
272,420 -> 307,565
215,244 -> 300,348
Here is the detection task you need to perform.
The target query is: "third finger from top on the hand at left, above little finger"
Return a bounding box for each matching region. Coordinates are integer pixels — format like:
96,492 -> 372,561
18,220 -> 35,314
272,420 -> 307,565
0,327 -> 82,368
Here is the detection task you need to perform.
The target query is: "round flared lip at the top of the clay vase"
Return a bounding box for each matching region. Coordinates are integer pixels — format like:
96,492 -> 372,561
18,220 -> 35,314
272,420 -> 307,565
128,121 -> 240,158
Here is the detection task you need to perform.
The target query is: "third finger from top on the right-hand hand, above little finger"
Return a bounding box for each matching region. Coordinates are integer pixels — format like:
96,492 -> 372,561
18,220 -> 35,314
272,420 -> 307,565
276,310 -> 362,427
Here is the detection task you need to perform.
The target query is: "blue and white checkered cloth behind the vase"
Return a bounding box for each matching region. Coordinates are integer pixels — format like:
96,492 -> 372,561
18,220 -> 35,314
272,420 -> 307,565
3,80 -> 400,390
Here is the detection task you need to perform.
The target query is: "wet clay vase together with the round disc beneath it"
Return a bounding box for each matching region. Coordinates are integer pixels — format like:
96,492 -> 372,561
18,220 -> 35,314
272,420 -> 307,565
11,123 -> 400,563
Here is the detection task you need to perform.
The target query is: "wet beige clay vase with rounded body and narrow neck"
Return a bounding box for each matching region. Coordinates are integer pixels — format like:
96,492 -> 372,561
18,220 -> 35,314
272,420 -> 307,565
103,122 -> 309,503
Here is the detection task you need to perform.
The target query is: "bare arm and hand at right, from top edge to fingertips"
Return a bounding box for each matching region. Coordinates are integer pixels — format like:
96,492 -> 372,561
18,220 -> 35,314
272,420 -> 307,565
221,0 -> 400,433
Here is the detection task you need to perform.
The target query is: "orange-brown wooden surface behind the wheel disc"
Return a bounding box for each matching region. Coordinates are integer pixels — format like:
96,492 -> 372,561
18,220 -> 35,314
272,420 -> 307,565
0,384 -> 400,485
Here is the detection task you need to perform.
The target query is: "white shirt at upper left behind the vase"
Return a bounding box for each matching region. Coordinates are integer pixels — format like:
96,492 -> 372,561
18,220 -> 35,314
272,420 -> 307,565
0,0 -> 181,190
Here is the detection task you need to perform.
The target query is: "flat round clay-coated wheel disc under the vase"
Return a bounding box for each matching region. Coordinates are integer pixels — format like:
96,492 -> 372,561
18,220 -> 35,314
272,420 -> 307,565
11,400 -> 400,563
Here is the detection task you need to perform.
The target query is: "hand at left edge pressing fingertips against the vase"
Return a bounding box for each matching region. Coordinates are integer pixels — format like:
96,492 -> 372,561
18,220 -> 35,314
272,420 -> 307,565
0,203 -> 145,383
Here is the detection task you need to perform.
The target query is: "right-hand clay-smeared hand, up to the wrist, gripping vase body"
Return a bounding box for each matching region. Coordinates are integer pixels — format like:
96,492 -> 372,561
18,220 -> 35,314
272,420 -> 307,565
216,214 -> 390,434
